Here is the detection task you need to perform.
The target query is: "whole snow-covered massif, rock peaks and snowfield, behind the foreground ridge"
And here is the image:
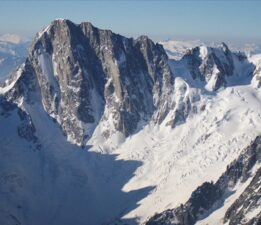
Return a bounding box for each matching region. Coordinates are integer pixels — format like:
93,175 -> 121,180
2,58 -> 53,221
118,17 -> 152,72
0,19 -> 261,225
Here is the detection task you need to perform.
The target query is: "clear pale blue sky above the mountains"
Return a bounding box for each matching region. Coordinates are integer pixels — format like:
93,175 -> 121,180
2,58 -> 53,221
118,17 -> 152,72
0,0 -> 261,42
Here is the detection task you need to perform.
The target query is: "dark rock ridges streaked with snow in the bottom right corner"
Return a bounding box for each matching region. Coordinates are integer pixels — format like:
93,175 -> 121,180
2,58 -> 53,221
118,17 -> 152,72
146,136 -> 261,225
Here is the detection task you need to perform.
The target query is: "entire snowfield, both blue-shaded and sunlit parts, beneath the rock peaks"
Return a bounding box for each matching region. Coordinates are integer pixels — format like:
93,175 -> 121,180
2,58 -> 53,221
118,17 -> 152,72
0,20 -> 261,225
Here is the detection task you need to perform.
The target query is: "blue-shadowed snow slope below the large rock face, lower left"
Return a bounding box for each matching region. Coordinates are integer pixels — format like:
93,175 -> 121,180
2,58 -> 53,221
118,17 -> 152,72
0,99 -> 151,225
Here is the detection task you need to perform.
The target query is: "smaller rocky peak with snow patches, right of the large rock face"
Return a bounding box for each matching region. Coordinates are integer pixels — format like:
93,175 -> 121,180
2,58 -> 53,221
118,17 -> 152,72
179,42 -> 253,91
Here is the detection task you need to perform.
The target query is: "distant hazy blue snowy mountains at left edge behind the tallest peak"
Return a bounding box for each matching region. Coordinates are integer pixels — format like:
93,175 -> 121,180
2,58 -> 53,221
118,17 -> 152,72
0,34 -> 31,81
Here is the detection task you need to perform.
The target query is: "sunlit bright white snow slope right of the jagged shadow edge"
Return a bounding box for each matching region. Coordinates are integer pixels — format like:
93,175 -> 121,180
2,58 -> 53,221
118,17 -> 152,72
87,57 -> 261,223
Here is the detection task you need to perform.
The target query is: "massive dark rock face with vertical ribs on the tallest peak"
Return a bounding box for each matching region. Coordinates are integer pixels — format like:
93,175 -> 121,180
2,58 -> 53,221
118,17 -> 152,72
6,20 -> 173,144
